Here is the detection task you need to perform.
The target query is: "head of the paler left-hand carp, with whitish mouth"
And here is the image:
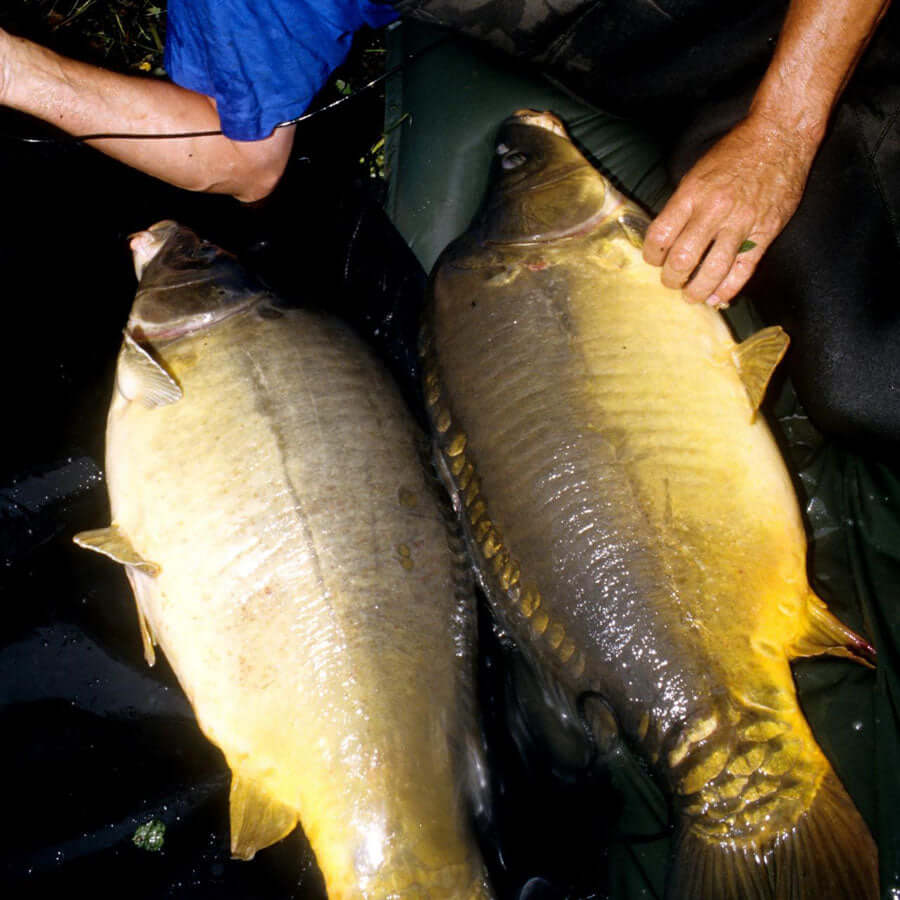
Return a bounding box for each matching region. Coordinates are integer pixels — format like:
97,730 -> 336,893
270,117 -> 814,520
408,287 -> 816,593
126,220 -> 269,342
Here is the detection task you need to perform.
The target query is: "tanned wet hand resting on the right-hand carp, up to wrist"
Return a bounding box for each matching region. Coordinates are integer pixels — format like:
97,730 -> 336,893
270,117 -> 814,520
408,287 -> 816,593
644,115 -> 817,307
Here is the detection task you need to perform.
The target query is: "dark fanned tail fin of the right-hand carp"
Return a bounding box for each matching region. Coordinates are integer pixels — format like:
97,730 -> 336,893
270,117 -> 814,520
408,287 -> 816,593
666,770 -> 878,900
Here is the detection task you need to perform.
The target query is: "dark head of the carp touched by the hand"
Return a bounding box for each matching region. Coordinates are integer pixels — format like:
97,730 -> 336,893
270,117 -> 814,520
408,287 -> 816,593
476,109 -> 623,244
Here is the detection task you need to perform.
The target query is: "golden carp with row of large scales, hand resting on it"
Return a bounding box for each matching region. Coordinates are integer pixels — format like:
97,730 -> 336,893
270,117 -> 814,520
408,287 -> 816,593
421,110 -> 878,900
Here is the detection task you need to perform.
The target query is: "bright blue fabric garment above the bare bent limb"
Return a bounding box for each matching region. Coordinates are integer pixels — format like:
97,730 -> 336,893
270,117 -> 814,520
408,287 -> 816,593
165,0 -> 397,141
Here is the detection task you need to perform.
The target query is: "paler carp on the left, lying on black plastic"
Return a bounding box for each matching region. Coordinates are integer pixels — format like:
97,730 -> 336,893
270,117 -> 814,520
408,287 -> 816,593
76,222 -> 500,900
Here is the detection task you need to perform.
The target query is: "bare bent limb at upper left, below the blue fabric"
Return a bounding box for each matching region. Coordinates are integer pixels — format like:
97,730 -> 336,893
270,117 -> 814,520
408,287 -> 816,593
0,30 -> 294,202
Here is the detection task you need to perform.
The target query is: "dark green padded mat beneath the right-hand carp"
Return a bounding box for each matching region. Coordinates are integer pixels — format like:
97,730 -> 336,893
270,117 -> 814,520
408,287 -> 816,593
385,24 -> 900,900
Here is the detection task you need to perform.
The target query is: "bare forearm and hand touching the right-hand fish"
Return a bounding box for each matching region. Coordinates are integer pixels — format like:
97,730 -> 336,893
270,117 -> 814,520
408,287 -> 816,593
644,0 -> 890,306
